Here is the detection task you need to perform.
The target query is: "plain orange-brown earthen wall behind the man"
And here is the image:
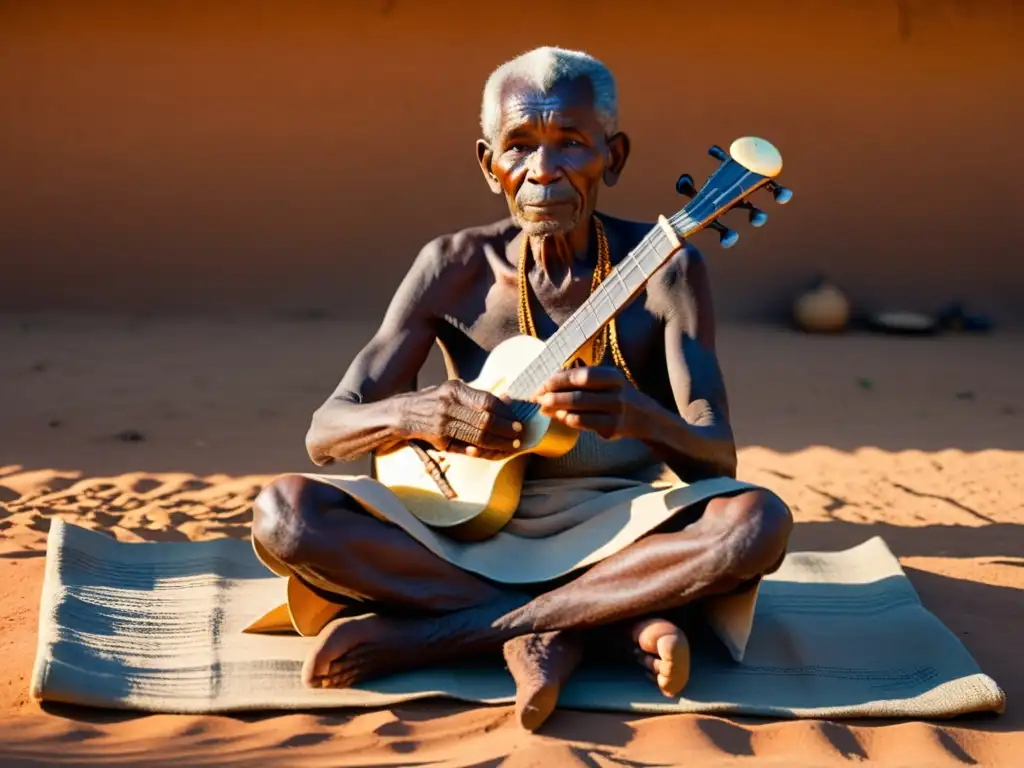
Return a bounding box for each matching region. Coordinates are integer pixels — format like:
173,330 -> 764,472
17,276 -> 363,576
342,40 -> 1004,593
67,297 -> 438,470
0,0 -> 1024,319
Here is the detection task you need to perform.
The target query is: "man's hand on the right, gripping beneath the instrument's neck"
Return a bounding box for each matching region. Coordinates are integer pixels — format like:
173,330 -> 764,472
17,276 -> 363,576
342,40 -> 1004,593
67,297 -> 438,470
532,366 -> 641,440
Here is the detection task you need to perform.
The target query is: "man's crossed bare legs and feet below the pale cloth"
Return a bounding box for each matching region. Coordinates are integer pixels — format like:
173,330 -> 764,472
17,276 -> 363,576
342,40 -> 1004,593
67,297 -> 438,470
253,475 -> 793,728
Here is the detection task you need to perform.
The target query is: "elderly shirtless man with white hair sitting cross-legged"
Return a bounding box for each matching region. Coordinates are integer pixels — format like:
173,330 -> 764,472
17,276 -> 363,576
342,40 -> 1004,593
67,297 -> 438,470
253,48 -> 792,729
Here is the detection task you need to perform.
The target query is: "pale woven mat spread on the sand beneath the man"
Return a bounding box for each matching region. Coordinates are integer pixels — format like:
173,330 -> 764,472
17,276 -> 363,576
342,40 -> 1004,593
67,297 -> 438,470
32,519 -> 1006,718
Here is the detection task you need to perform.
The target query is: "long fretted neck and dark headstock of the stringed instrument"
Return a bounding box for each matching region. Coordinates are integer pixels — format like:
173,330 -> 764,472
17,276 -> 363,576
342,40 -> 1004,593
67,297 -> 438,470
506,158 -> 768,419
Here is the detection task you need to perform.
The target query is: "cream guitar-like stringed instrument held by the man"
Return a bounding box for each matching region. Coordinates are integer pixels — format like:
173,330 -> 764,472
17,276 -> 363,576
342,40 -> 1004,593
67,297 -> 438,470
374,136 -> 792,541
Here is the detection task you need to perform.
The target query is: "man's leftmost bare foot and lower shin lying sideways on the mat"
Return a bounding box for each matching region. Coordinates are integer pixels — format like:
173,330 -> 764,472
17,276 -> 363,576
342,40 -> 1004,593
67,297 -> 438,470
302,596 -> 524,688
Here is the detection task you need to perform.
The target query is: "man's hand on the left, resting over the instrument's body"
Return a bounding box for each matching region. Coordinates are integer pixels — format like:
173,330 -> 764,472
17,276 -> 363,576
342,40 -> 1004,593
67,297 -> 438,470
403,379 -> 522,459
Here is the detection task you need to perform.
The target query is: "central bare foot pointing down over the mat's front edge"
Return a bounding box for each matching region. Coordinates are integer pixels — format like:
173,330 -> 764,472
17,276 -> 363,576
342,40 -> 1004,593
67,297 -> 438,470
503,632 -> 583,731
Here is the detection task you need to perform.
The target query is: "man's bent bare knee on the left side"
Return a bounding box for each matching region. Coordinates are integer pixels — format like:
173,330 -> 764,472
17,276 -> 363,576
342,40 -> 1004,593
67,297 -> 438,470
252,474 -> 315,565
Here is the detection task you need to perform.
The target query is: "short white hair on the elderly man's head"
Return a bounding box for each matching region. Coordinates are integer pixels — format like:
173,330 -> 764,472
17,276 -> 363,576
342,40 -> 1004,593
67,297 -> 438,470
480,45 -> 618,141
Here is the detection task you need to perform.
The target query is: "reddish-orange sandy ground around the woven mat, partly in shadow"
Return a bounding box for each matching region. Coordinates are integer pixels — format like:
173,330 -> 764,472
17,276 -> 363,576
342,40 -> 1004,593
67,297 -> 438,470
0,314 -> 1024,768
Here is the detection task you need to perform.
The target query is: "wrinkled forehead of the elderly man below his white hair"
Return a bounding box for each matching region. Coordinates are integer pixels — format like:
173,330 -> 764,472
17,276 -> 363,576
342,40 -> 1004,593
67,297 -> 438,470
501,78 -> 598,132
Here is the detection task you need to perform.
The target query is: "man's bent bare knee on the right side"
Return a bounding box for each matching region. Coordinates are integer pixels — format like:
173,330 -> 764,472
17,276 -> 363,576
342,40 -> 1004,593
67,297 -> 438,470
726,489 -> 793,577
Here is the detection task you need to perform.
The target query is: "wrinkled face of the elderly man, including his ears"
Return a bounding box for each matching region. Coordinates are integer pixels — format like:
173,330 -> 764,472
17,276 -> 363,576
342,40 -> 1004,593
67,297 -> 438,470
479,78 -> 625,236
